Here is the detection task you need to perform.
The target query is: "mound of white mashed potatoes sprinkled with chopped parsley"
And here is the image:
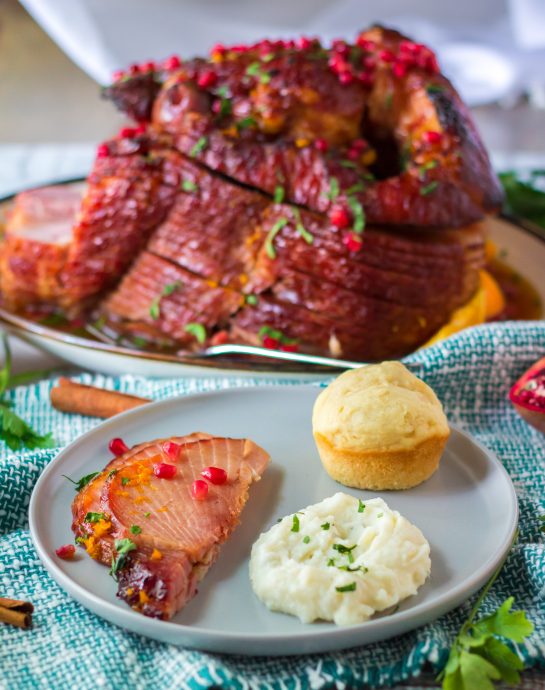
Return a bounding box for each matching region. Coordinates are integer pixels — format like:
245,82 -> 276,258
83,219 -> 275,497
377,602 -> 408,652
250,493 -> 430,625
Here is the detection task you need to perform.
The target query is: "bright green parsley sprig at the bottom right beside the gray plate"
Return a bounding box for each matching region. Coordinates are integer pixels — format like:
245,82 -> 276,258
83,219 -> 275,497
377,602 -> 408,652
437,544 -> 534,690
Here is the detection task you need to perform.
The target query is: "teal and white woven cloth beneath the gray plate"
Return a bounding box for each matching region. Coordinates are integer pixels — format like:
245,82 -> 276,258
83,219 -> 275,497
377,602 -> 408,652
0,322 -> 545,690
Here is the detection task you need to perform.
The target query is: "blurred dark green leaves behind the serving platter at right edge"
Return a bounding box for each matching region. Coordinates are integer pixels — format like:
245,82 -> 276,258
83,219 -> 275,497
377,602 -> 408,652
499,170 -> 545,228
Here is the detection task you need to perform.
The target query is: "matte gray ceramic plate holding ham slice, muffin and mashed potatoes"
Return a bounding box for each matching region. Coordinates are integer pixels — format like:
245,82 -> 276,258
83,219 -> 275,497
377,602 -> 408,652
30,386 -> 518,655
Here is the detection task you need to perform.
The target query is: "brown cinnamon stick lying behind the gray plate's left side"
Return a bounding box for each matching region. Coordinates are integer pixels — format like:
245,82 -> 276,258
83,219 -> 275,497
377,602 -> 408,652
51,377 -> 151,419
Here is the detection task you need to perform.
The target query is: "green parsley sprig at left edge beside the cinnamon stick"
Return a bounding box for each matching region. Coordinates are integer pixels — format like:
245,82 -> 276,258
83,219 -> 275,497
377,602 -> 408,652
0,333 -> 55,451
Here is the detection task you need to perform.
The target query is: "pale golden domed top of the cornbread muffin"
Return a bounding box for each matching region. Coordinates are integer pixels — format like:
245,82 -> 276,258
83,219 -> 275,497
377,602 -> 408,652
312,362 -> 450,451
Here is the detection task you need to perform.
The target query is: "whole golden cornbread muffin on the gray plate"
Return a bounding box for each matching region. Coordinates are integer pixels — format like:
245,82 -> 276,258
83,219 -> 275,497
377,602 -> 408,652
312,362 -> 450,491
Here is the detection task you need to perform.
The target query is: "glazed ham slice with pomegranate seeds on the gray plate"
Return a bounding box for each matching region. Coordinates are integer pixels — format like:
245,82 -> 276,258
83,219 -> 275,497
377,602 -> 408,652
72,433 -> 269,620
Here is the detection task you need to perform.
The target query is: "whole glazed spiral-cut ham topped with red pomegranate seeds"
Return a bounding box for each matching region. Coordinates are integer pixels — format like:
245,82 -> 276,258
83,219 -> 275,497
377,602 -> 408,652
0,27 -> 501,360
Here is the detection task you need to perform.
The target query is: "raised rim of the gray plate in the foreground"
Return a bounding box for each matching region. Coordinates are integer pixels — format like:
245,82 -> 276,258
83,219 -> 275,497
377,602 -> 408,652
28,384 -> 519,656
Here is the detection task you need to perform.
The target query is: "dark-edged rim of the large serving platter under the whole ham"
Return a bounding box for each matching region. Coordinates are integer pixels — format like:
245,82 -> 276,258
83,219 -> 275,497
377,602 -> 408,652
0,177 -> 545,377
